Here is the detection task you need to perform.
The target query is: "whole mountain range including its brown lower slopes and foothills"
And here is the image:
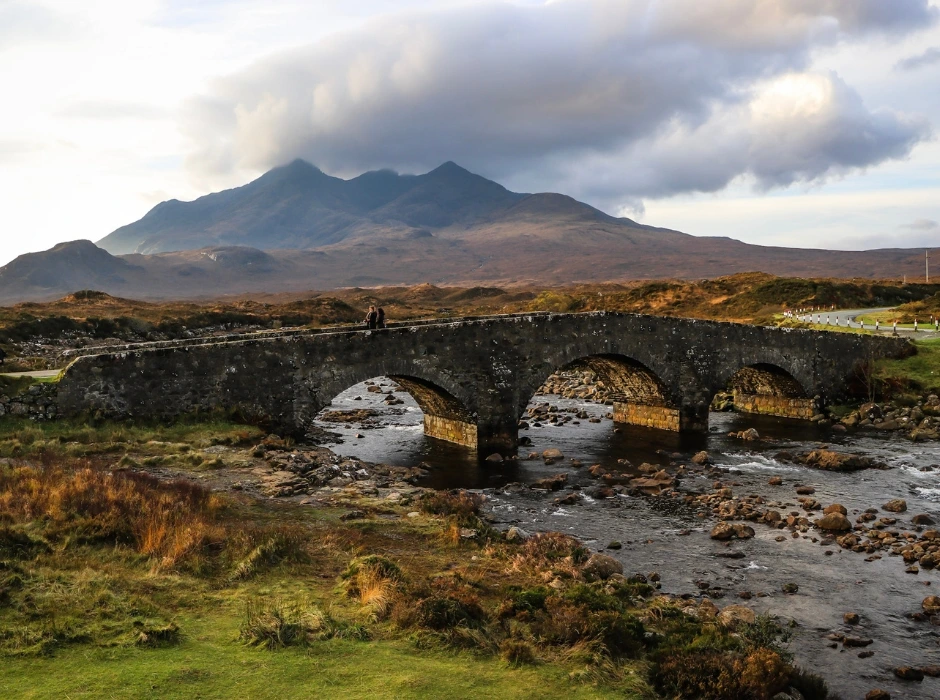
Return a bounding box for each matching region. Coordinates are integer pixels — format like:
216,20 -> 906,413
0,160 -> 936,303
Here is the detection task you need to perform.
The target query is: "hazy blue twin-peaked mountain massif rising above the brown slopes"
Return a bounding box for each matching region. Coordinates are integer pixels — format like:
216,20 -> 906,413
98,160 -> 525,255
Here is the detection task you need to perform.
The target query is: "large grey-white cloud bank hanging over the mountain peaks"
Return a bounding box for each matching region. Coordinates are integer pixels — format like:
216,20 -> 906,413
184,0 -> 937,208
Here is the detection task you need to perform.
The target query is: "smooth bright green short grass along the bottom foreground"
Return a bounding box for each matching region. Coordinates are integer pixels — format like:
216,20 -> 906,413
0,615 -> 642,700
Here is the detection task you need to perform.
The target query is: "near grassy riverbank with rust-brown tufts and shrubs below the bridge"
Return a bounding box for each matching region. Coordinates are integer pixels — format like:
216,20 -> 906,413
0,421 -> 826,700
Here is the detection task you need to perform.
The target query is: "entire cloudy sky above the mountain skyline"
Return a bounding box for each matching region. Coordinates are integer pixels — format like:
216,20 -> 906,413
0,0 -> 940,264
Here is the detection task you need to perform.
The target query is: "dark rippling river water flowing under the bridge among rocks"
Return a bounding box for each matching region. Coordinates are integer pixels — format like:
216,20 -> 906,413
322,380 -> 940,699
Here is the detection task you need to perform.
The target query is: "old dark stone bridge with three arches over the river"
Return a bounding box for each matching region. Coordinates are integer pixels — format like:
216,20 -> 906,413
58,312 -> 912,451
